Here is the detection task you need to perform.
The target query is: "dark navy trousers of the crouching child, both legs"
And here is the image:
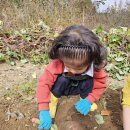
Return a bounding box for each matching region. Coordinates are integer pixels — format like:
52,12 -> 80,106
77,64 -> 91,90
51,75 -> 93,99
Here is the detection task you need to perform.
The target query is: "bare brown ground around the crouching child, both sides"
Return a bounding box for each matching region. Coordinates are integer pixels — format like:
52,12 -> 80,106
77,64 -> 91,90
0,63 -> 123,130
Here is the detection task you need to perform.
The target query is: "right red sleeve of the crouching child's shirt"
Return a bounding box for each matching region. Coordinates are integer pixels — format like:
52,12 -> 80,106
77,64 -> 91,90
86,69 -> 107,103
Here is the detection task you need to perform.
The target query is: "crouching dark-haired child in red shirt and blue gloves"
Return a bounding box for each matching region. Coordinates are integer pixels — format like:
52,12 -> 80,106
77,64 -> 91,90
37,26 -> 107,129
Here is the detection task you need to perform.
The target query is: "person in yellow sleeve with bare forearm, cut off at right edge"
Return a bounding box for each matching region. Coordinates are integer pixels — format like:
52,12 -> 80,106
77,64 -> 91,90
122,75 -> 130,130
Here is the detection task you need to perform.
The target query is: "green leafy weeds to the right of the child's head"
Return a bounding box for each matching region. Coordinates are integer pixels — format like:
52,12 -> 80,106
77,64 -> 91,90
94,27 -> 130,80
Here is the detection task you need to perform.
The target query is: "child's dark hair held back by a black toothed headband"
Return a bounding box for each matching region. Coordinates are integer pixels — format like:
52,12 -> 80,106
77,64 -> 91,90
49,25 -> 107,70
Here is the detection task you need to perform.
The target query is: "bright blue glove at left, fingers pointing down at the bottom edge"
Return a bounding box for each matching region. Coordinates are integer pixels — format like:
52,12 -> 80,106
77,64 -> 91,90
38,110 -> 52,130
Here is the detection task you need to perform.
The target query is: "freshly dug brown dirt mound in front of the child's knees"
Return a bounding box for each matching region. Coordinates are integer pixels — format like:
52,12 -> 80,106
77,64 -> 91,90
55,89 -> 123,130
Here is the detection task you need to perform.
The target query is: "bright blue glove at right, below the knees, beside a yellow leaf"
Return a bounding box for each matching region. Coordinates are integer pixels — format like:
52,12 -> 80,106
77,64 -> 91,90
75,99 -> 91,116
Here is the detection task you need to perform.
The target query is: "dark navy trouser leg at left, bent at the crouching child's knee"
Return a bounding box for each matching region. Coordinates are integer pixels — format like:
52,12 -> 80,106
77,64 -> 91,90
51,75 -> 70,98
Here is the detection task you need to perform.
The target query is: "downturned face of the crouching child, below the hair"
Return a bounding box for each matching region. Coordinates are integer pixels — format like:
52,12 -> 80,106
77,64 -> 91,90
62,59 -> 88,74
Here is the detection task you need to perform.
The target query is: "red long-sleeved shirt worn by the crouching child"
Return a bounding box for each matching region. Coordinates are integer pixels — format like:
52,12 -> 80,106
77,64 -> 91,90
37,60 -> 107,110
